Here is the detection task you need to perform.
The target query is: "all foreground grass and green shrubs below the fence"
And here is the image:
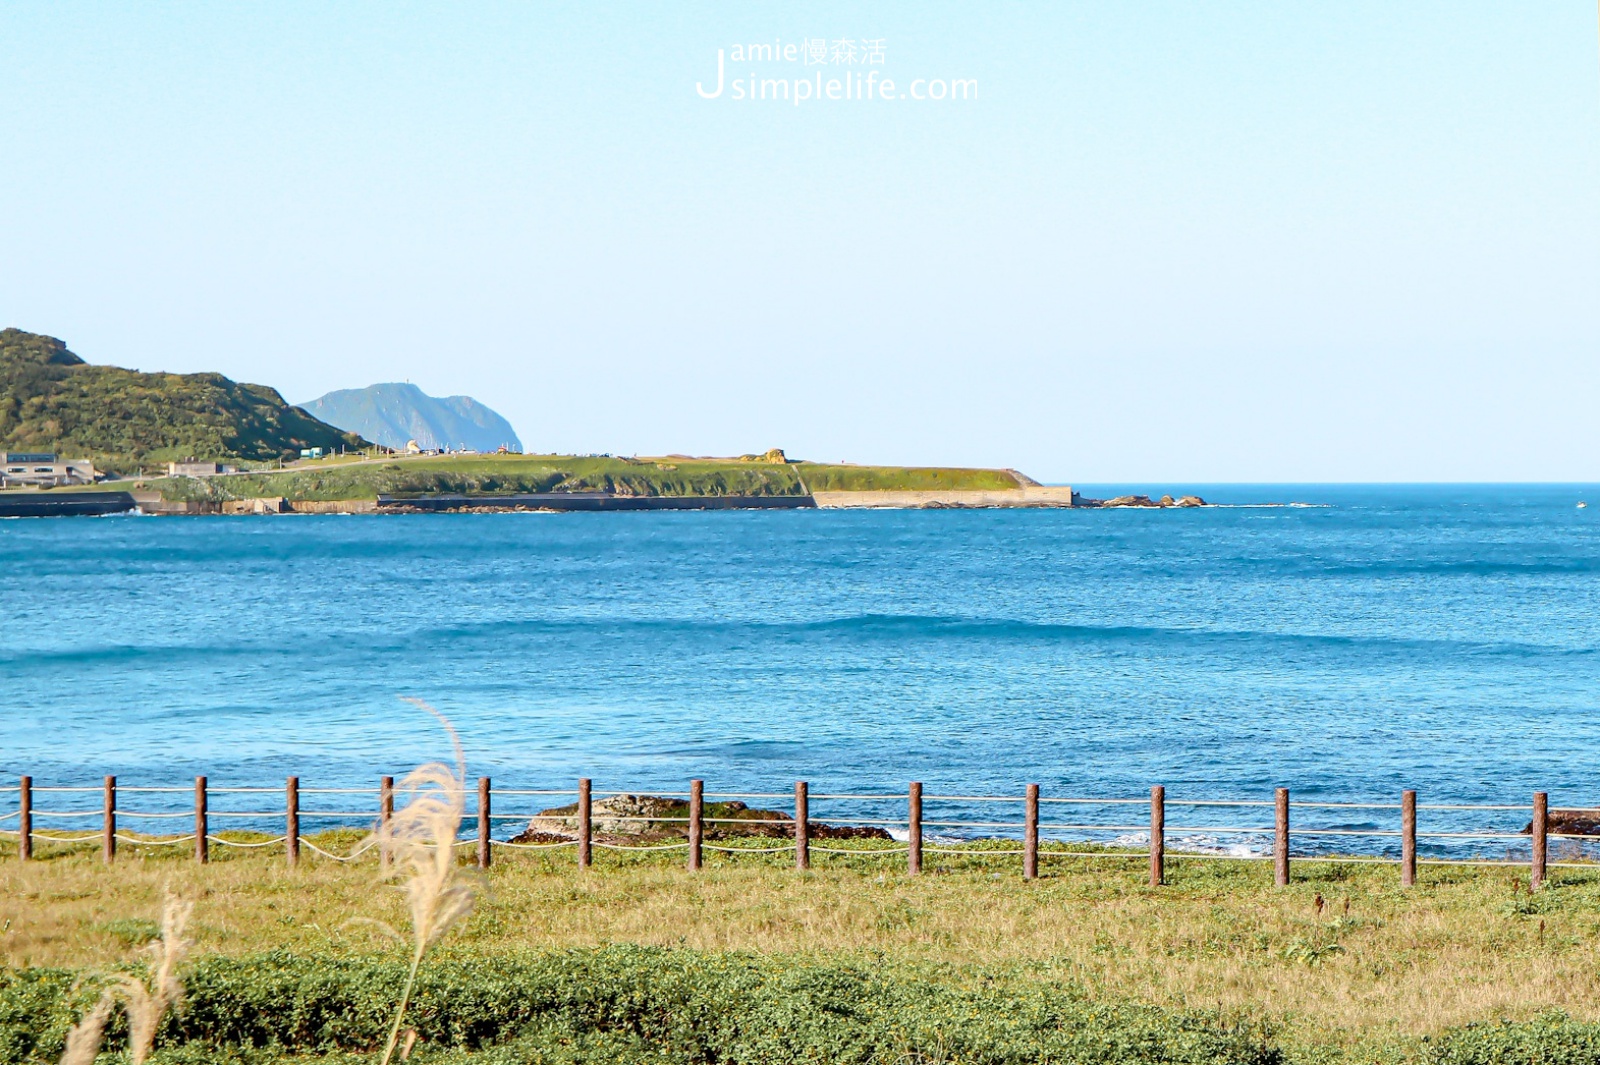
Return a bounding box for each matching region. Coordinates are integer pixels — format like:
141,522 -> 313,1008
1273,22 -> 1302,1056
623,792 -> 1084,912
0,833 -> 1600,1065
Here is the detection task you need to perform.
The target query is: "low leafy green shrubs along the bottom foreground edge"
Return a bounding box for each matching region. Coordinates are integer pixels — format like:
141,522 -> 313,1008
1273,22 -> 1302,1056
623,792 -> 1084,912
0,947 -> 1280,1065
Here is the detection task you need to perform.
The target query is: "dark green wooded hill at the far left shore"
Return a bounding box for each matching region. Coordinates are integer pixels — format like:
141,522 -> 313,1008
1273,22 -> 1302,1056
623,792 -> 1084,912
0,329 -> 370,470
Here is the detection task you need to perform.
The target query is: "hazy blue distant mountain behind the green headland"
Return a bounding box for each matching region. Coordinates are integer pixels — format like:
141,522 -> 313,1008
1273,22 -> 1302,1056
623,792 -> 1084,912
302,382 -> 522,451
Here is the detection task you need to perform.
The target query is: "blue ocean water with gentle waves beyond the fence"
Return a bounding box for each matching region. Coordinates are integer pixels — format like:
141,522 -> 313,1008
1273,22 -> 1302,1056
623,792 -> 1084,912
0,486 -> 1600,846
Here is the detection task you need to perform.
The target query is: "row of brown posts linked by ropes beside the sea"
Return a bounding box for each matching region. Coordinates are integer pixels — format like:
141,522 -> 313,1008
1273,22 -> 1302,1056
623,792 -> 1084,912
0,777 -> 1600,891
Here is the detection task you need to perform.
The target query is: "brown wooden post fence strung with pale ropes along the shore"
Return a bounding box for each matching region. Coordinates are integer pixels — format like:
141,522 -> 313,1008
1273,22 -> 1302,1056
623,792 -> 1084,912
0,776 -> 1600,891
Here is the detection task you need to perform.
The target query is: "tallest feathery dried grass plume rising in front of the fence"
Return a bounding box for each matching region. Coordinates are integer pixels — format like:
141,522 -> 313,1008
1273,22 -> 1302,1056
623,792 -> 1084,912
373,699 -> 475,1065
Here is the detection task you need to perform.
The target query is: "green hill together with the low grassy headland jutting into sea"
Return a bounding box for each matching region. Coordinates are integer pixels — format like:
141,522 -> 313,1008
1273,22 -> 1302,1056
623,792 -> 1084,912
0,329 -> 1019,502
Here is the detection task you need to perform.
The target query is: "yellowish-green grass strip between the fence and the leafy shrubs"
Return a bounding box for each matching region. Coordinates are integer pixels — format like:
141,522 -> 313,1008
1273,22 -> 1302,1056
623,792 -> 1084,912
0,835 -> 1600,1062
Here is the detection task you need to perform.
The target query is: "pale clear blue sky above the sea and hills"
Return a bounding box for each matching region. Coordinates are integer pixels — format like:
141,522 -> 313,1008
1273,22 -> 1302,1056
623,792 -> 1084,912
0,0 -> 1600,483
